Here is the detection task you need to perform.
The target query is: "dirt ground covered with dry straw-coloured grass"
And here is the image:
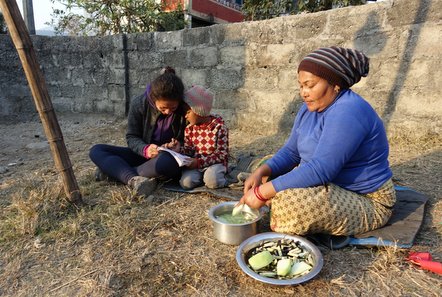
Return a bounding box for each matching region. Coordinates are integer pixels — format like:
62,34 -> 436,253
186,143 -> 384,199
0,114 -> 442,296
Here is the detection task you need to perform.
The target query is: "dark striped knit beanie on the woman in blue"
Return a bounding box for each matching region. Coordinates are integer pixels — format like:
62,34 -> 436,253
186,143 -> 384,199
298,46 -> 369,89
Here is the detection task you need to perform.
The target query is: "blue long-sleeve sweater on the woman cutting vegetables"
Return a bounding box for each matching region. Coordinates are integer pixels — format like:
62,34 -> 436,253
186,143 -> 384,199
267,90 -> 392,194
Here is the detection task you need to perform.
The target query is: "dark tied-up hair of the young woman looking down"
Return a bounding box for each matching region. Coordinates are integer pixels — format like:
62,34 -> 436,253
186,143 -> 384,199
149,66 -> 184,101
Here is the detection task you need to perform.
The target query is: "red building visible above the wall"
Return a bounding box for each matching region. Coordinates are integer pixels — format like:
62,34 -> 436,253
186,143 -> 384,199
159,0 -> 244,28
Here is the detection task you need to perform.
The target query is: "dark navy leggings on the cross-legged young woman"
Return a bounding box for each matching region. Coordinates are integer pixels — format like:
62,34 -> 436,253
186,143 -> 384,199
89,144 -> 181,184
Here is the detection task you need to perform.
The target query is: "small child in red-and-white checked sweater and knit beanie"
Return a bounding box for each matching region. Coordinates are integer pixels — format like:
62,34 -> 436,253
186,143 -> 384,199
167,85 -> 229,189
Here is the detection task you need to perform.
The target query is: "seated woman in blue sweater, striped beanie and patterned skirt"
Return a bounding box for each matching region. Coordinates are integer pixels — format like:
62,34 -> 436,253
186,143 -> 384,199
241,47 -> 396,239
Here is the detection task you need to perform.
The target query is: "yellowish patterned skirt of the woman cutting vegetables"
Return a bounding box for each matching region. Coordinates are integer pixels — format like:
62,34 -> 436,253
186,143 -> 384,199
270,179 -> 396,235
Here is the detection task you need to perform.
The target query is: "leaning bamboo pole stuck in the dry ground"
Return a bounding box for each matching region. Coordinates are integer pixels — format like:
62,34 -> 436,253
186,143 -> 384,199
0,0 -> 83,205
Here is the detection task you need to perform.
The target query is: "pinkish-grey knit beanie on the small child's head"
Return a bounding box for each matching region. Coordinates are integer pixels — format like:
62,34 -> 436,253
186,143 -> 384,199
184,85 -> 213,117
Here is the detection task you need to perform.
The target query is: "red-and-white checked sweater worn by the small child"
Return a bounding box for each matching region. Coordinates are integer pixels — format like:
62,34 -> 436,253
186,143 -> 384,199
182,115 -> 229,168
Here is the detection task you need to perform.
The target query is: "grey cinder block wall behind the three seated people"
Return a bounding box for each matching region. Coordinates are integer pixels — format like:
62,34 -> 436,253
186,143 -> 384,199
0,0 -> 442,137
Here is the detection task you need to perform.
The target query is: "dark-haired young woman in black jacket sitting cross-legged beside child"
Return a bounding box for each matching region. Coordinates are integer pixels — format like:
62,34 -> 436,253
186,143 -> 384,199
89,67 -> 186,196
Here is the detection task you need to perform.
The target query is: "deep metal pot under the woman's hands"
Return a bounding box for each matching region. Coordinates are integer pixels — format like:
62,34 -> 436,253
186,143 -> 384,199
209,201 -> 262,245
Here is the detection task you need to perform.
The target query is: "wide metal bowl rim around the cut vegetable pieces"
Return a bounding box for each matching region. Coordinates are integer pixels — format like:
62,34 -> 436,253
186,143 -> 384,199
236,232 -> 324,286
